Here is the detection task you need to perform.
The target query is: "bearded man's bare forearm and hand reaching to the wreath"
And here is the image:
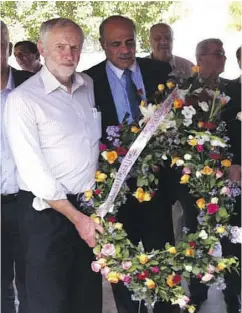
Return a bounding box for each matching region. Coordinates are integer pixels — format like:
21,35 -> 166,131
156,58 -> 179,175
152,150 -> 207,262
46,199 -> 104,248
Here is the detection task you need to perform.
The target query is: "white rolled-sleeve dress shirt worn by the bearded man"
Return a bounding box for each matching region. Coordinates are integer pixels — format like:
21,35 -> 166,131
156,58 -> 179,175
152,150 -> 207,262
5,66 -> 101,210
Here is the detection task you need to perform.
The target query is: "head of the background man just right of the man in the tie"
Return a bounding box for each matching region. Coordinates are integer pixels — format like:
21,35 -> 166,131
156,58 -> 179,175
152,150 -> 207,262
150,23 -> 173,62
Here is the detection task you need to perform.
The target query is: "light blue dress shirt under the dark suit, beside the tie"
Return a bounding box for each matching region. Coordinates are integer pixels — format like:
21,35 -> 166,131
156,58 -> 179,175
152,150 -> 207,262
106,61 -> 146,123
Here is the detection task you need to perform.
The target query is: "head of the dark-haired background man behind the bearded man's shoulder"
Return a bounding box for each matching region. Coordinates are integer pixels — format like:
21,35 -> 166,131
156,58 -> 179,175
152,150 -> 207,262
14,40 -> 42,73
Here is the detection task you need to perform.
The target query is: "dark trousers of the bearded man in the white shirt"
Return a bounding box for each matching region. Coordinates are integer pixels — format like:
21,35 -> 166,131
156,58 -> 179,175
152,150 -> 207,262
19,191 -> 102,313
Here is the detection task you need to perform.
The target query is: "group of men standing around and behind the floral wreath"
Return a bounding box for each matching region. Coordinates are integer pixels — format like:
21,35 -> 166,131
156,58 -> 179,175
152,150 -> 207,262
1,16 -> 241,313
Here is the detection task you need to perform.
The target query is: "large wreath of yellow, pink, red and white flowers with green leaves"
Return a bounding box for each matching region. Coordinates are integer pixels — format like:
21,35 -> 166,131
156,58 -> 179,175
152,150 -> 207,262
78,67 -> 241,313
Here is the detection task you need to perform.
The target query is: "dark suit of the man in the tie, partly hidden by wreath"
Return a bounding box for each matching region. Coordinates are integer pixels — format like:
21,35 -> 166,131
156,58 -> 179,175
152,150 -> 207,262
86,58 -> 174,250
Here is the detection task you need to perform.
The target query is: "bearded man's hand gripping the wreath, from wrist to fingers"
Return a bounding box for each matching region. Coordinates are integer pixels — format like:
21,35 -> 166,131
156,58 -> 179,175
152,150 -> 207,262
74,212 -> 103,248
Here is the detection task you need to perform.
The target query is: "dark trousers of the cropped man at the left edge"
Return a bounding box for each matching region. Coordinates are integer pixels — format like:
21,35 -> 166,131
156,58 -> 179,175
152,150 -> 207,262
1,198 -> 27,313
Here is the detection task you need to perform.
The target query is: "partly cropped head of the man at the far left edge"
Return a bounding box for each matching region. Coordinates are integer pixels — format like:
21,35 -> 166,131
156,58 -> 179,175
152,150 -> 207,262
1,21 -> 12,75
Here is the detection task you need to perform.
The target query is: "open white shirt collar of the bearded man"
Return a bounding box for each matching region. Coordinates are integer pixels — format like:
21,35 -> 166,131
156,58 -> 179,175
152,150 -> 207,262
39,65 -> 86,94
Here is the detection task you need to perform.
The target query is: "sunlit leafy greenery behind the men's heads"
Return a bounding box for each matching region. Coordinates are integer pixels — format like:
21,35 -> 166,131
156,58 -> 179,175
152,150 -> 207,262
0,1 -> 174,50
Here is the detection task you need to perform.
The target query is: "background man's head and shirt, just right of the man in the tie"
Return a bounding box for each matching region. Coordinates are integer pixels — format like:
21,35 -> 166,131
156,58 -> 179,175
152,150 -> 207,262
150,23 -> 193,77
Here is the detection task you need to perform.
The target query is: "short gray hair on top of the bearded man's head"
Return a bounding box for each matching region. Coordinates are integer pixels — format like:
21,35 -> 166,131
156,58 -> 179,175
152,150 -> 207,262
40,17 -> 84,41
